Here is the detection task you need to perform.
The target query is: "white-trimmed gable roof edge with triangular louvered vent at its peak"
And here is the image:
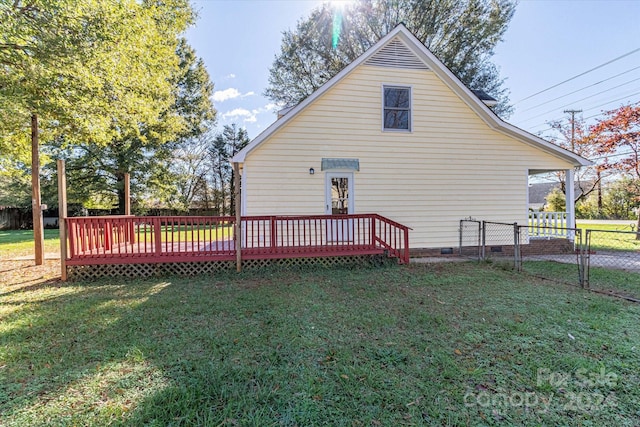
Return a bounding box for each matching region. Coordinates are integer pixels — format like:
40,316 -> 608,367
231,24 -> 592,168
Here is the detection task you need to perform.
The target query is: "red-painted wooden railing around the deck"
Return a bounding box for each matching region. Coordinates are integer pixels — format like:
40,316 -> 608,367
66,214 -> 409,265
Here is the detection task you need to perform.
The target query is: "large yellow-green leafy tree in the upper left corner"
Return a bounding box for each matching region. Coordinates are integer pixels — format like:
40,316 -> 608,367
0,0 -> 193,264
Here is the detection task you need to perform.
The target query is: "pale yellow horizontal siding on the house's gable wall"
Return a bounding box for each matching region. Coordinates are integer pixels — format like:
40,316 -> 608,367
243,65 -> 572,248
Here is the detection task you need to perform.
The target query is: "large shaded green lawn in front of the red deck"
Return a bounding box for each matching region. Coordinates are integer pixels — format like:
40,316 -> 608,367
0,261 -> 640,426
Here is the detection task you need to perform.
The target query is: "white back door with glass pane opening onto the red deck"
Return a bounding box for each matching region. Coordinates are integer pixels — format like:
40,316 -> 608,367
325,172 -> 354,242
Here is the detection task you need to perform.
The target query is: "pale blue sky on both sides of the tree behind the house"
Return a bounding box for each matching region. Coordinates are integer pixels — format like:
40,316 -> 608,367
187,0 -> 640,138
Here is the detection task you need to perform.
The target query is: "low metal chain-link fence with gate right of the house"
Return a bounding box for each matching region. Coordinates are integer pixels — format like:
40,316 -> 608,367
460,219 -> 640,302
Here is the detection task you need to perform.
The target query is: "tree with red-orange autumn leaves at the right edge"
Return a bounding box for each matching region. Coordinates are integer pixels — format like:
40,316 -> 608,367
590,103 -> 640,236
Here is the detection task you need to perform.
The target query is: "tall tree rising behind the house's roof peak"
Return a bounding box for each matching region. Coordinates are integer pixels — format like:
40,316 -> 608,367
265,0 -> 515,116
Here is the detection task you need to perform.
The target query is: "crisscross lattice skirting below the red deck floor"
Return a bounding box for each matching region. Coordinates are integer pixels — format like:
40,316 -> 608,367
67,255 -> 390,280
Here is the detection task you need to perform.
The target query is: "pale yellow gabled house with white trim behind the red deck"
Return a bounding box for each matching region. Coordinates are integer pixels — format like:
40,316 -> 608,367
232,25 -> 590,249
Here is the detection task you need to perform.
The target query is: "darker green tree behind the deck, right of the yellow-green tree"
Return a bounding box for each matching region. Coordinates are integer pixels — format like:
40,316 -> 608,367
53,39 -> 216,214
